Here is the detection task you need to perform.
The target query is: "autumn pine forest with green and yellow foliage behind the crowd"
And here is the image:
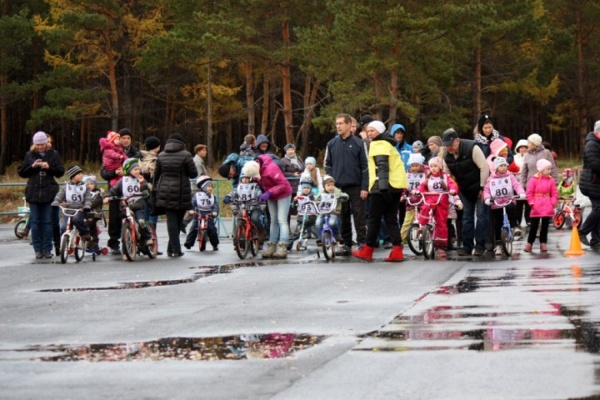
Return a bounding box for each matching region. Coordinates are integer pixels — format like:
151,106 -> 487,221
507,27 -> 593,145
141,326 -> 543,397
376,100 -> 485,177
0,0 -> 600,175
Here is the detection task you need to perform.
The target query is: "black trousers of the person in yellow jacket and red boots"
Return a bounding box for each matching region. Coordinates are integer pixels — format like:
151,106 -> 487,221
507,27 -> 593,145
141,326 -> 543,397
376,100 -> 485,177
363,192 -> 406,247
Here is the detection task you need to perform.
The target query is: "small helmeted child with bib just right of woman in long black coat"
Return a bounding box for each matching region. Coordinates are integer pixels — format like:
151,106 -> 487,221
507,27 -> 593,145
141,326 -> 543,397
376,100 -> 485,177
184,175 -> 219,251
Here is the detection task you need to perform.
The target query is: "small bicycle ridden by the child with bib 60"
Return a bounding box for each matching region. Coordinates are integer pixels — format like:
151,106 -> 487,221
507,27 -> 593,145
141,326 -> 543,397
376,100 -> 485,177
121,198 -> 158,261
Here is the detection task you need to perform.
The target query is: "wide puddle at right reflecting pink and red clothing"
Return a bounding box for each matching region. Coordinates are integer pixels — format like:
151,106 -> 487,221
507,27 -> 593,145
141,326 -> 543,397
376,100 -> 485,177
356,266 -> 600,353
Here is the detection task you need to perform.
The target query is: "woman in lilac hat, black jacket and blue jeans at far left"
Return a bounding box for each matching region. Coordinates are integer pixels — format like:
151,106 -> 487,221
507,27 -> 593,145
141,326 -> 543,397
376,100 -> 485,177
17,131 -> 65,259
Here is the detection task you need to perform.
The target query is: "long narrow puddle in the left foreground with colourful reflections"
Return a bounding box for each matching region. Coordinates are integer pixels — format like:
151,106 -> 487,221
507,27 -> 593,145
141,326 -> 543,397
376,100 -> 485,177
0,333 -> 325,362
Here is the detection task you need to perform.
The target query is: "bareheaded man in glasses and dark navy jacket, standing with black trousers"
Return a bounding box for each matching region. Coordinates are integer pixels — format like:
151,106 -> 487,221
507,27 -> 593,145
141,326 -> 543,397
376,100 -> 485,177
325,114 -> 369,255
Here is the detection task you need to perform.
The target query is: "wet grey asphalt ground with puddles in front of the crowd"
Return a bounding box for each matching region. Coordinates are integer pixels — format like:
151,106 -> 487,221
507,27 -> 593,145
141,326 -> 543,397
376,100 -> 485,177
0,223 -> 600,399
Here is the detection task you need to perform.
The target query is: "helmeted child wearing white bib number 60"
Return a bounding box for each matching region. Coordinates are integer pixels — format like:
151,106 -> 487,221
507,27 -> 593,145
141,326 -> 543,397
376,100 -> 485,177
104,158 -> 154,248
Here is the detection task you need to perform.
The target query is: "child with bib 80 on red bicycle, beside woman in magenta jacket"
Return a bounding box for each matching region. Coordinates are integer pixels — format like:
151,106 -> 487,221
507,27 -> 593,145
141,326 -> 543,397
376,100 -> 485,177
231,173 -> 267,246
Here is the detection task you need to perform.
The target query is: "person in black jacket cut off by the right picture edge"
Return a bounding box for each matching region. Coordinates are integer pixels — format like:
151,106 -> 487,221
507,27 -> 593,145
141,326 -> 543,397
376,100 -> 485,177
579,121 -> 600,251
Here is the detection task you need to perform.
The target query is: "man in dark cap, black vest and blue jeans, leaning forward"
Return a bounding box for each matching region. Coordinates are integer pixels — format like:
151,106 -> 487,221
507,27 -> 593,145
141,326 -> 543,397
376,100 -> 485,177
442,129 -> 490,256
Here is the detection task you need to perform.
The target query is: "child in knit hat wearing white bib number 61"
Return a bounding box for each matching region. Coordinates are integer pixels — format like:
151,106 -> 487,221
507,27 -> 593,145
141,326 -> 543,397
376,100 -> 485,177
52,165 -> 92,241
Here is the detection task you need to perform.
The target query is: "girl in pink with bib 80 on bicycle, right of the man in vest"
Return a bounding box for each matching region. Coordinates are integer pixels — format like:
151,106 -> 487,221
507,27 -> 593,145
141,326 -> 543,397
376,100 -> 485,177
483,156 -> 525,254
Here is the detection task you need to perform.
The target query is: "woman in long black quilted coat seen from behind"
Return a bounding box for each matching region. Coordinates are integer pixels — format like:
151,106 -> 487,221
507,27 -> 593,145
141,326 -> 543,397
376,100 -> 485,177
155,133 -> 198,257
